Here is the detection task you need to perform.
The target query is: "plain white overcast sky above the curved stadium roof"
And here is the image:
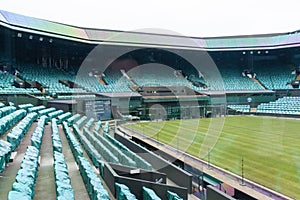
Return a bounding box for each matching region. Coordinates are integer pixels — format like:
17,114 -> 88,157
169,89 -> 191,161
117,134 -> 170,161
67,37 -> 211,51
0,0 -> 300,37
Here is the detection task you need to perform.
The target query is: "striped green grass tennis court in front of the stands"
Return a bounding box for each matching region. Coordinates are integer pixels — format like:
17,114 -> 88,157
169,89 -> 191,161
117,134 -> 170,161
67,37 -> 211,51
126,116 -> 300,199
